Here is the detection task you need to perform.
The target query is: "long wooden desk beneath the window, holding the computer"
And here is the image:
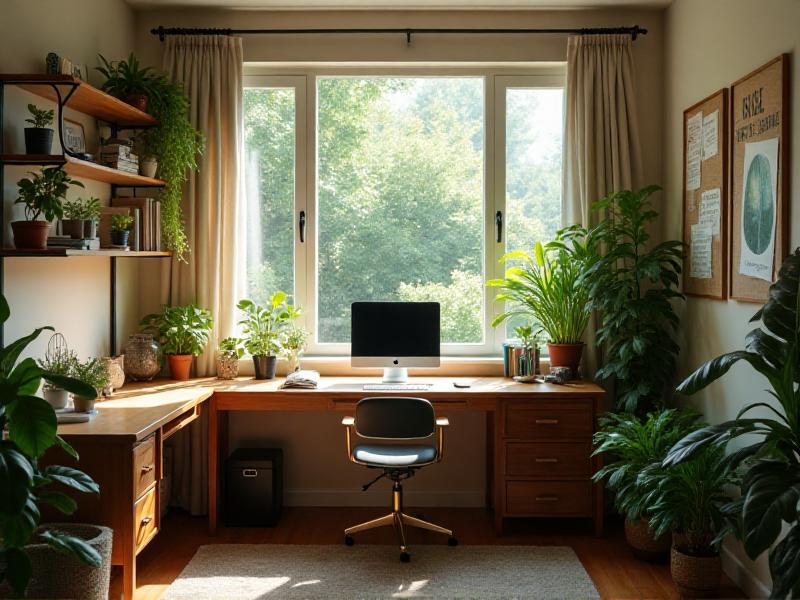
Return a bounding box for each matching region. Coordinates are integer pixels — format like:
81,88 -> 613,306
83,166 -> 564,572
208,377 -> 604,536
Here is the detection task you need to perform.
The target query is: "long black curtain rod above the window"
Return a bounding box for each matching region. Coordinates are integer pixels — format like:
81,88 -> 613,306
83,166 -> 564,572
150,25 -> 647,44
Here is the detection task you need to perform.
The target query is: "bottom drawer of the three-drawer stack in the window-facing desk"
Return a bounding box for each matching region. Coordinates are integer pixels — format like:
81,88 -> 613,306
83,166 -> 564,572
506,481 -> 592,517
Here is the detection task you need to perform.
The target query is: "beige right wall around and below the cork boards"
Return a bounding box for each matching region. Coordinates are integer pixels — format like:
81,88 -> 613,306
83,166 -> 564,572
664,0 -> 800,595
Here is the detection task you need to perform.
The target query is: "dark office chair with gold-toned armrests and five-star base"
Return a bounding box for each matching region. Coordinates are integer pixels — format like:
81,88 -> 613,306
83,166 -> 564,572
342,396 -> 458,562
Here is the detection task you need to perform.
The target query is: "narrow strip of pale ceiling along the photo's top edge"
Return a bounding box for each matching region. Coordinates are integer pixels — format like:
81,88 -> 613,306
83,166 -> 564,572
127,0 -> 672,10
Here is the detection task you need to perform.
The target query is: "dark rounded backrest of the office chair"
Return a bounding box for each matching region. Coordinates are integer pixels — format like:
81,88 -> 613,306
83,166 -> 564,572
355,396 -> 436,440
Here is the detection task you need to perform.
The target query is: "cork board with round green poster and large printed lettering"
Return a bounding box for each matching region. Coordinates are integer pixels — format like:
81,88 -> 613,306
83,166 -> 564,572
730,54 -> 790,303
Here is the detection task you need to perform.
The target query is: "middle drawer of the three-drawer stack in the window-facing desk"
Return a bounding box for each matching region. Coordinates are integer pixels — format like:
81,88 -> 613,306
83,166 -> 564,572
505,442 -> 592,479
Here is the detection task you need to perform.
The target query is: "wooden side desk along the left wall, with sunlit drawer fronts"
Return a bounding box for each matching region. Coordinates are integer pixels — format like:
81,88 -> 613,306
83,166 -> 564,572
44,382 -> 214,600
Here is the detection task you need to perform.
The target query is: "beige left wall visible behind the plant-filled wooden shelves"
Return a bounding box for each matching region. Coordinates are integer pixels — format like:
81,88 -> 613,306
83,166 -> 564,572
0,0 -> 139,358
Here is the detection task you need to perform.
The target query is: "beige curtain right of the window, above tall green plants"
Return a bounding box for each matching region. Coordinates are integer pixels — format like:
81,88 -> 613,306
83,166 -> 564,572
562,35 -> 643,376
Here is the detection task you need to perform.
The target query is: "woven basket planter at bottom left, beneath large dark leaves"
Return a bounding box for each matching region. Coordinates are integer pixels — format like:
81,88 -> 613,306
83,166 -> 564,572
0,523 -> 112,600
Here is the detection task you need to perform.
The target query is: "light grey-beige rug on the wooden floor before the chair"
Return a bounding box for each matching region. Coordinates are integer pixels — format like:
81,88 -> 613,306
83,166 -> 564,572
164,544 -> 600,600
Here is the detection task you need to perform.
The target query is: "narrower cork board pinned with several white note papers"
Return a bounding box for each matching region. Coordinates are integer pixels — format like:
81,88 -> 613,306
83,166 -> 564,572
683,89 -> 729,300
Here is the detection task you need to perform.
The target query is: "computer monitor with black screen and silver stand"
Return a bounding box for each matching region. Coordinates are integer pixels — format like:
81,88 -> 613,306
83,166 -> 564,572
350,302 -> 440,383
